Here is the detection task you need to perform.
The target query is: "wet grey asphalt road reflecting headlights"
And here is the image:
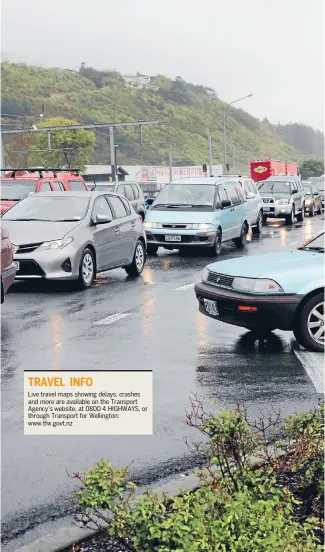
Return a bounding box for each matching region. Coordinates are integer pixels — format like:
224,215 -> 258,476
2,216 -> 324,539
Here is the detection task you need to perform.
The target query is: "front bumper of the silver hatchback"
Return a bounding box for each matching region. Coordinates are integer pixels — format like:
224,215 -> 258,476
14,244 -> 80,281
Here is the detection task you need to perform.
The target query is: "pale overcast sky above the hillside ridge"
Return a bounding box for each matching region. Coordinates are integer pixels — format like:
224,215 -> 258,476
2,0 -> 324,130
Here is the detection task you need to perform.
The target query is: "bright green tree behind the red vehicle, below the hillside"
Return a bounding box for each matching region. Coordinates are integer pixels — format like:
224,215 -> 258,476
29,117 -> 96,170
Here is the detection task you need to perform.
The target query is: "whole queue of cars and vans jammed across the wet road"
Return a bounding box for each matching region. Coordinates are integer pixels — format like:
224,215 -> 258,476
1,168 -> 325,351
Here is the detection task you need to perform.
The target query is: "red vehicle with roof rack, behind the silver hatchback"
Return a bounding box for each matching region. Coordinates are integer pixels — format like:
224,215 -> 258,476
0,169 -> 88,213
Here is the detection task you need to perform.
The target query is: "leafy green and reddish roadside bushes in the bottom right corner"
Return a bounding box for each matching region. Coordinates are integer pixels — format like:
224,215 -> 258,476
74,400 -> 324,552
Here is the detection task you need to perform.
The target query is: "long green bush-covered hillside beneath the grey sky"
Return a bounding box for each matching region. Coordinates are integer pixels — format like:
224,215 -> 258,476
2,63 -> 316,170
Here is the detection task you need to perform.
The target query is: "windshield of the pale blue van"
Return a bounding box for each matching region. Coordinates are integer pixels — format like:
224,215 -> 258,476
152,184 -> 215,208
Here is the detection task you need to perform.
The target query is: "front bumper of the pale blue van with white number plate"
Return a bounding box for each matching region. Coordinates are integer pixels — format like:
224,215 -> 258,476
146,229 -> 216,249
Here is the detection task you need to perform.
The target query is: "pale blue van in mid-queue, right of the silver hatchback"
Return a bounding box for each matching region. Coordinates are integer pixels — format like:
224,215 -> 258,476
144,177 -> 249,255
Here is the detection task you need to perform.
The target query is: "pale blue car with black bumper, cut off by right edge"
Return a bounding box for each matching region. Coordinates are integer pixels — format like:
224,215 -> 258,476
195,233 -> 325,352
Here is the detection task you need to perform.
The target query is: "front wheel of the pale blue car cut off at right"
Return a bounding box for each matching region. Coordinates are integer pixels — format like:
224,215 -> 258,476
293,293 -> 325,352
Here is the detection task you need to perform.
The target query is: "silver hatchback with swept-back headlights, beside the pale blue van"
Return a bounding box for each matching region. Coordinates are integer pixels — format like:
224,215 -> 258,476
2,192 -> 147,288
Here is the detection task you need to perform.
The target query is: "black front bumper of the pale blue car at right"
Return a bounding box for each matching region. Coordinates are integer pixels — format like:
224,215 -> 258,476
194,282 -> 301,330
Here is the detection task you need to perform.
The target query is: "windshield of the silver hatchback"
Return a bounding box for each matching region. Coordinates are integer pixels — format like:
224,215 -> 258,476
2,194 -> 89,222
